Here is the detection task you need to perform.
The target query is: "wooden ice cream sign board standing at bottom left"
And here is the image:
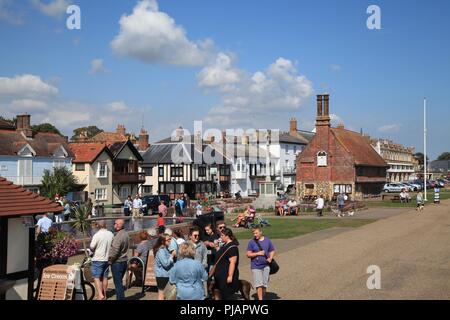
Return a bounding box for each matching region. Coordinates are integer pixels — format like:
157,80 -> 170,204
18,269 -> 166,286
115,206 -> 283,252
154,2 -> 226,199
38,264 -> 76,300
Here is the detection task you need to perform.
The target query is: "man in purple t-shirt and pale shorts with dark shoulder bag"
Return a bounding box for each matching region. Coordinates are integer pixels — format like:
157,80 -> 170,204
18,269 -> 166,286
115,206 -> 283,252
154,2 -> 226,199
247,227 -> 275,300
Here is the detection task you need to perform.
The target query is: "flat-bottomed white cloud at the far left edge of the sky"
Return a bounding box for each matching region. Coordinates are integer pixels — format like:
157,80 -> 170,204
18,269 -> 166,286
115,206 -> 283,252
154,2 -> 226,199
0,74 -> 58,98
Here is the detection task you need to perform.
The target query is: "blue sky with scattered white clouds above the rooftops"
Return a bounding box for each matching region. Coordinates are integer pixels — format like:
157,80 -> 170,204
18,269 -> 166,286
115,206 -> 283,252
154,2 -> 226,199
0,0 -> 450,159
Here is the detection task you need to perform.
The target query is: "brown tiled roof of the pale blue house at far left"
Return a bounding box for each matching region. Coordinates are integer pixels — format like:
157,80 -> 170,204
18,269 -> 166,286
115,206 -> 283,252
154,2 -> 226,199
0,130 -> 73,157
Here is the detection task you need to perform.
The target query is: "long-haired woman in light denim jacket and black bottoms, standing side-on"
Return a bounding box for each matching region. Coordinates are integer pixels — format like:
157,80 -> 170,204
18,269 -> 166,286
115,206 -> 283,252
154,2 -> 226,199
153,235 -> 173,300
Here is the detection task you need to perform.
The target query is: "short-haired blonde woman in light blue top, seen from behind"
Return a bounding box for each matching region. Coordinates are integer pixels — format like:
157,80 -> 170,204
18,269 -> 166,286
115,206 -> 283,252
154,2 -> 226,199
169,242 -> 208,300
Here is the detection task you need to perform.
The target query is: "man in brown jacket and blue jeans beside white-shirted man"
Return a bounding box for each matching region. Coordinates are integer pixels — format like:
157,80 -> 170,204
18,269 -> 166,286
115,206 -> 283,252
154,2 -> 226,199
109,219 -> 130,300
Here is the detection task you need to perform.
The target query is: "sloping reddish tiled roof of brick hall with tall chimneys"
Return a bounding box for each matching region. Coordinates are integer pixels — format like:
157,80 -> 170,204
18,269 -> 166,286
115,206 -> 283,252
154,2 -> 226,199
330,128 -> 388,167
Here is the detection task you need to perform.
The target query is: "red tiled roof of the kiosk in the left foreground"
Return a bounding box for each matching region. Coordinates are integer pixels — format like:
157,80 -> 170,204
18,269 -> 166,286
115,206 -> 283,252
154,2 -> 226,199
0,177 -> 64,217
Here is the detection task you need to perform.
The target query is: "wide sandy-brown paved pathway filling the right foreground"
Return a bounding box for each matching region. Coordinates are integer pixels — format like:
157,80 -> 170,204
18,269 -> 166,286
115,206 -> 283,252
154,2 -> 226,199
103,201 -> 450,300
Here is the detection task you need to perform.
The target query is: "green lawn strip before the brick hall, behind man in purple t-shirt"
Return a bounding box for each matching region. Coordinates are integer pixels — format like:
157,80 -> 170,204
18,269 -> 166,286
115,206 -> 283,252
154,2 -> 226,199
232,218 -> 376,239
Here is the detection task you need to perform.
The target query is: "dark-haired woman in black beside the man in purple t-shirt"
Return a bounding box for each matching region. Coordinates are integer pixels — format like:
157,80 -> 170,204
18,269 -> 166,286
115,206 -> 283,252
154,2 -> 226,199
210,228 -> 239,300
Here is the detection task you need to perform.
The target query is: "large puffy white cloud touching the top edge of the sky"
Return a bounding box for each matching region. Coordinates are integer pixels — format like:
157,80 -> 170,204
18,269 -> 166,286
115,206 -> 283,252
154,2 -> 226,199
111,0 -> 212,65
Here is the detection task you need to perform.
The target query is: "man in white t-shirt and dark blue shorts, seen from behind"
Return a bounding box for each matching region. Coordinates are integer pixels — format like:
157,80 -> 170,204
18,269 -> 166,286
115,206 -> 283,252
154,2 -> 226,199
89,220 -> 114,300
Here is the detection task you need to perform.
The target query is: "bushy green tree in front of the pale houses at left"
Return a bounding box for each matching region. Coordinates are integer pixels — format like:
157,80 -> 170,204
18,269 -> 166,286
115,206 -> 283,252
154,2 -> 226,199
41,167 -> 77,199
